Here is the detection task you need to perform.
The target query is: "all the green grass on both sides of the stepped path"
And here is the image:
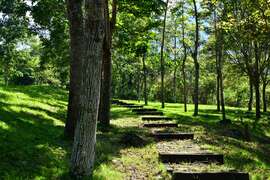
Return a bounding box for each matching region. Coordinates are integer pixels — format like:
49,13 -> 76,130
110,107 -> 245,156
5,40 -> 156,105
0,86 -> 270,180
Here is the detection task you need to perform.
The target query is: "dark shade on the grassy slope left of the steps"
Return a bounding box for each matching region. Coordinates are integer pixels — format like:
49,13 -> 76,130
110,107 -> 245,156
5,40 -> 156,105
0,87 -> 152,179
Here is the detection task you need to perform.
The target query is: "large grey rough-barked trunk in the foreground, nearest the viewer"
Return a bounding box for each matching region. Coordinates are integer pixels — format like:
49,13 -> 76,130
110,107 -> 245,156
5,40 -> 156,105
68,0 -> 105,179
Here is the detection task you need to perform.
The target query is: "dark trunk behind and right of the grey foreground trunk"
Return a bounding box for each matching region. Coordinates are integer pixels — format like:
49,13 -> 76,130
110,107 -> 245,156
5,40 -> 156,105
98,0 -> 117,126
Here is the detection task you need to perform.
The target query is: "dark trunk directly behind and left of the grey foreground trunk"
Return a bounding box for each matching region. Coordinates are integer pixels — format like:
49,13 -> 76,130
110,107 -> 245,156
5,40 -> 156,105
64,0 -> 83,139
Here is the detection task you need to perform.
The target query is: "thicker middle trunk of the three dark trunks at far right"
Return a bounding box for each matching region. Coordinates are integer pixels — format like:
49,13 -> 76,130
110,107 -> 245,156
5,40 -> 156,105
254,42 -> 261,119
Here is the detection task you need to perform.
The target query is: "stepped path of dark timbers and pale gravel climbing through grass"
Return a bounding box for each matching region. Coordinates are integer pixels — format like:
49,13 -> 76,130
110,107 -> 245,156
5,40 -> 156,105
112,100 -> 249,180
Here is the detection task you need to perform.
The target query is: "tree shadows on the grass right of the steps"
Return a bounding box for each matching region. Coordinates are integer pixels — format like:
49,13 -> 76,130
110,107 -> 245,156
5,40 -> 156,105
161,110 -> 270,176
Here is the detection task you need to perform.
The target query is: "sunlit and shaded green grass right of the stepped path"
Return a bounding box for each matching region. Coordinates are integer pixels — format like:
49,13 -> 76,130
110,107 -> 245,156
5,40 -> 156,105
127,101 -> 270,180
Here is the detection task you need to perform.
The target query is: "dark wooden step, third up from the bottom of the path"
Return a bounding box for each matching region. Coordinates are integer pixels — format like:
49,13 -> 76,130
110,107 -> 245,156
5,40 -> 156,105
152,133 -> 194,140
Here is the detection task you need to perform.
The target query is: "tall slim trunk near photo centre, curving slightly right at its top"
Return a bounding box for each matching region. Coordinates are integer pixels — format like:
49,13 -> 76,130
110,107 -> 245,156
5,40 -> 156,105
160,0 -> 169,108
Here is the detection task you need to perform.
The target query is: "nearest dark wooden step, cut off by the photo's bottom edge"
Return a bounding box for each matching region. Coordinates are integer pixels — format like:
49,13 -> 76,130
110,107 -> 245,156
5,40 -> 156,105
172,171 -> 249,180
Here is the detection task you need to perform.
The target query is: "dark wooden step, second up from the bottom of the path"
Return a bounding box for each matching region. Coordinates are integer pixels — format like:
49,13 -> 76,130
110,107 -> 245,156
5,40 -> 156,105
159,153 -> 224,164
